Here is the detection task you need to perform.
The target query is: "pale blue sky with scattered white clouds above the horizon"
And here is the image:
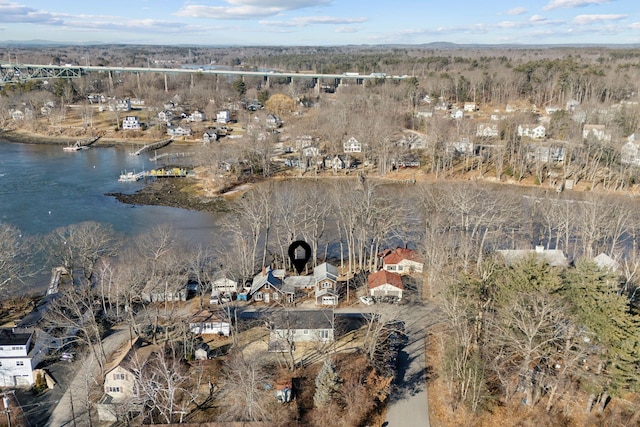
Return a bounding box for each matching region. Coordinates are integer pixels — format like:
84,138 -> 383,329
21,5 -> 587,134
0,0 -> 640,46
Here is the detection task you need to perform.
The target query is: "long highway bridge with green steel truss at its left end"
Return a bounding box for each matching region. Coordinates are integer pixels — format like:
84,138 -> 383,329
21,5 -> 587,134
0,61 -> 412,87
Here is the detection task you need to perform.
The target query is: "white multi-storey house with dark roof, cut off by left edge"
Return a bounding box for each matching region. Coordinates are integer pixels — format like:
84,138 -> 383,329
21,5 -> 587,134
0,329 -> 33,387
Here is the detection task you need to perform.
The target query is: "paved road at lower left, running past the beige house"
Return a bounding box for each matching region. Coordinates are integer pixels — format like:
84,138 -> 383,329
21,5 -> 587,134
47,328 -> 129,427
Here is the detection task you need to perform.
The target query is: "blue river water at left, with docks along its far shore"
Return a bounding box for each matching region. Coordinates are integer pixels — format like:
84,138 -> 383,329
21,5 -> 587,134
0,141 -> 220,292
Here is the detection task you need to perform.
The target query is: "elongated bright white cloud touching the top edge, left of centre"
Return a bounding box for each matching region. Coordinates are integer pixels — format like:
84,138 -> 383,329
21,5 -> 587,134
176,0 -> 330,19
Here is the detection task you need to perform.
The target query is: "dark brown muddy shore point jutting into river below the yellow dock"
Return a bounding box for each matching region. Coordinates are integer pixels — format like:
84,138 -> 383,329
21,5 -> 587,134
107,178 -> 227,212
